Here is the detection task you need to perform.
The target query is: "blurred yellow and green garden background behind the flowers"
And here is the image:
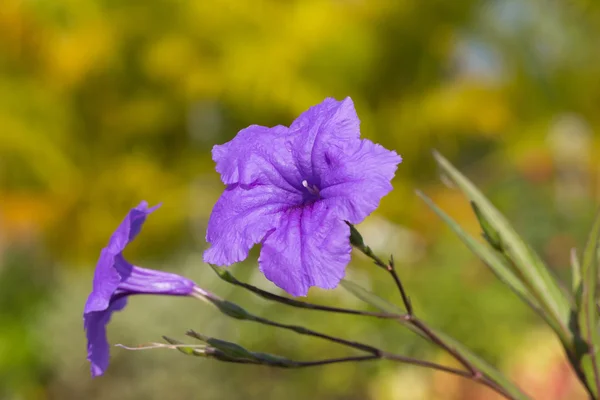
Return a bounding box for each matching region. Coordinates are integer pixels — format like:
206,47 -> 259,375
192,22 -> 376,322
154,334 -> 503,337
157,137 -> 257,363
0,0 -> 600,400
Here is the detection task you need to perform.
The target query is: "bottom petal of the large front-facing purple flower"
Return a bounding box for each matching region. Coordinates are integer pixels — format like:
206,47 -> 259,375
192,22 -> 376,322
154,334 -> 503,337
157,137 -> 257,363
258,202 -> 351,296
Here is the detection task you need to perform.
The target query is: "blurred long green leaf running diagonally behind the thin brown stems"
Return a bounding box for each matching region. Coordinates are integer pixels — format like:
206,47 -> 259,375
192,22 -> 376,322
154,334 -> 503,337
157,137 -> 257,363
341,279 -> 529,400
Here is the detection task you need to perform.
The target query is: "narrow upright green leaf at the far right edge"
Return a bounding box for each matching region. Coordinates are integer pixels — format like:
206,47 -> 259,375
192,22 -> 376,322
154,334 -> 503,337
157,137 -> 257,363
577,209 -> 600,398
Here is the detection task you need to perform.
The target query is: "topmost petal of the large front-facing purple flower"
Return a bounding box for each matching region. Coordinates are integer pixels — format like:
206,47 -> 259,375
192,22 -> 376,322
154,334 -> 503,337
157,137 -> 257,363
290,97 -> 360,185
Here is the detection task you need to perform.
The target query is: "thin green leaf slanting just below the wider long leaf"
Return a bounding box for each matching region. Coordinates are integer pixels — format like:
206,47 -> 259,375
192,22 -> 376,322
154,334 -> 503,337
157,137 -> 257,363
417,191 -> 551,321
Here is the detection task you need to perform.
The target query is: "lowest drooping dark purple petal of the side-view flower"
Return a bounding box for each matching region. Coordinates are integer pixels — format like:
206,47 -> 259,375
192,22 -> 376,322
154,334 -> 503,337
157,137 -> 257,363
83,297 -> 127,377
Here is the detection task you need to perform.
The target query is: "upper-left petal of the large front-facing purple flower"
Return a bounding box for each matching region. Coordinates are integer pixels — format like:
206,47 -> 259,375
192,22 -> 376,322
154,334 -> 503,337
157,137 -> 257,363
212,125 -> 302,189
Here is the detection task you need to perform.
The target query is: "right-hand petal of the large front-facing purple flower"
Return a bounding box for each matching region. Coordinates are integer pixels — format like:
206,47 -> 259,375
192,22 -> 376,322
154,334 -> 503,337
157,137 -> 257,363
320,139 -> 402,224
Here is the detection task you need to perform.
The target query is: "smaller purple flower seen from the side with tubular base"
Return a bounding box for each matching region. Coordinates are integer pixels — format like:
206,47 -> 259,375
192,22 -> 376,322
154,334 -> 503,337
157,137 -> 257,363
83,201 -> 195,377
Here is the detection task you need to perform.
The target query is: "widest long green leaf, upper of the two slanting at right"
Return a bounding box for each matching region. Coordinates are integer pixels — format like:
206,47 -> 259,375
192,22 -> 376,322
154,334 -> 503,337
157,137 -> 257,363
433,152 -> 575,354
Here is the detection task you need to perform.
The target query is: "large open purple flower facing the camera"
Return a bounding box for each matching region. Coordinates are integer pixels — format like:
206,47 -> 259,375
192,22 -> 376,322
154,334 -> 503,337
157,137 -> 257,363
204,98 -> 402,296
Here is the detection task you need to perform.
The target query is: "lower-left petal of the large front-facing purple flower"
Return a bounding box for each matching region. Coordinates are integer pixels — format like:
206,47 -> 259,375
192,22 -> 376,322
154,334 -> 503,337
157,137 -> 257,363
204,184 -> 302,265
